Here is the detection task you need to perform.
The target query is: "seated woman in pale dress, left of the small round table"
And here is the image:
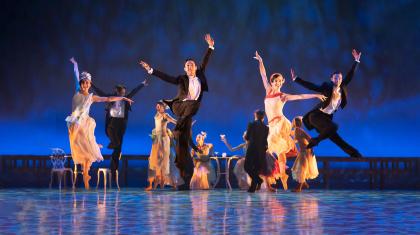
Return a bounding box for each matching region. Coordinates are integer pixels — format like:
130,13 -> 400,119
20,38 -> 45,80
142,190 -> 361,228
190,132 -> 216,190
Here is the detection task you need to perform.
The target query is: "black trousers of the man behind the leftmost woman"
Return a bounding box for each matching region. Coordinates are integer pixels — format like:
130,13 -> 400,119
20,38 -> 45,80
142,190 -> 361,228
106,117 -> 127,179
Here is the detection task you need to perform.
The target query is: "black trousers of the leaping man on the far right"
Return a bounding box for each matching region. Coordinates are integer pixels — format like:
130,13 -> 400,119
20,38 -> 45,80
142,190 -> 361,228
309,110 -> 358,155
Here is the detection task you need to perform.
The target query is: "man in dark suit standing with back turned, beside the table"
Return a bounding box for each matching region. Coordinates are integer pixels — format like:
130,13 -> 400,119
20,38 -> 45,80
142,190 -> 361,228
244,110 -> 269,193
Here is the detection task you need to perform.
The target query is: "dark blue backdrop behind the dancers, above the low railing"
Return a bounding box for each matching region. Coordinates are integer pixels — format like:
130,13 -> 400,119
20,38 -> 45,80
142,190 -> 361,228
0,0 -> 420,156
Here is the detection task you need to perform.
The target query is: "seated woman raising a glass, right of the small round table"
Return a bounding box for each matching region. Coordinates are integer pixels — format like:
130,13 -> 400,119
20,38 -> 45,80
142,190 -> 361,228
220,132 -> 251,189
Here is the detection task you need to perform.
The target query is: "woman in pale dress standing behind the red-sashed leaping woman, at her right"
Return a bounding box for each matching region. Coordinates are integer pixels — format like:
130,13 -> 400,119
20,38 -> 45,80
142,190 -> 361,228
292,117 -> 319,192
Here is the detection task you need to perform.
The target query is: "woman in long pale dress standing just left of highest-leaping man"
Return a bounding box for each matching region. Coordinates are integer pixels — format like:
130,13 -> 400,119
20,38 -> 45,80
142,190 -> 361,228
145,102 -> 176,191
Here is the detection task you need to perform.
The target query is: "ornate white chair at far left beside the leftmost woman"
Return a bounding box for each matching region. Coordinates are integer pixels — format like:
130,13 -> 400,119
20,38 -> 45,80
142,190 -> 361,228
50,148 -> 74,190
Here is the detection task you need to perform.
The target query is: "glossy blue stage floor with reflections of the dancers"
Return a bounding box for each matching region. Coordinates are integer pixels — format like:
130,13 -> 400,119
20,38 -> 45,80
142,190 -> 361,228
0,188 -> 420,234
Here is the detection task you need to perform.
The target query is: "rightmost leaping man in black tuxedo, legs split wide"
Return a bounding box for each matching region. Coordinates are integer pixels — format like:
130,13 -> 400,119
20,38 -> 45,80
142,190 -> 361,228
291,49 -> 362,158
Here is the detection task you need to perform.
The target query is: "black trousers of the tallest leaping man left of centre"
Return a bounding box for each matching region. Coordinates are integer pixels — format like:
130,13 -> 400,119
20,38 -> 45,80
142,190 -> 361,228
166,100 -> 200,186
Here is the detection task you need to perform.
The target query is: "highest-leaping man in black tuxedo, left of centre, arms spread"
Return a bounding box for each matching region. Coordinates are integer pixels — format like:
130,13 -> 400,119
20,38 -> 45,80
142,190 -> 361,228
140,34 -> 214,190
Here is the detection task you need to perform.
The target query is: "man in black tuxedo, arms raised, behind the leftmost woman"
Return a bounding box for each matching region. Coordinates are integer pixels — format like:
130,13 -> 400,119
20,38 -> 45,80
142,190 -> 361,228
92,80 -> 147,179
